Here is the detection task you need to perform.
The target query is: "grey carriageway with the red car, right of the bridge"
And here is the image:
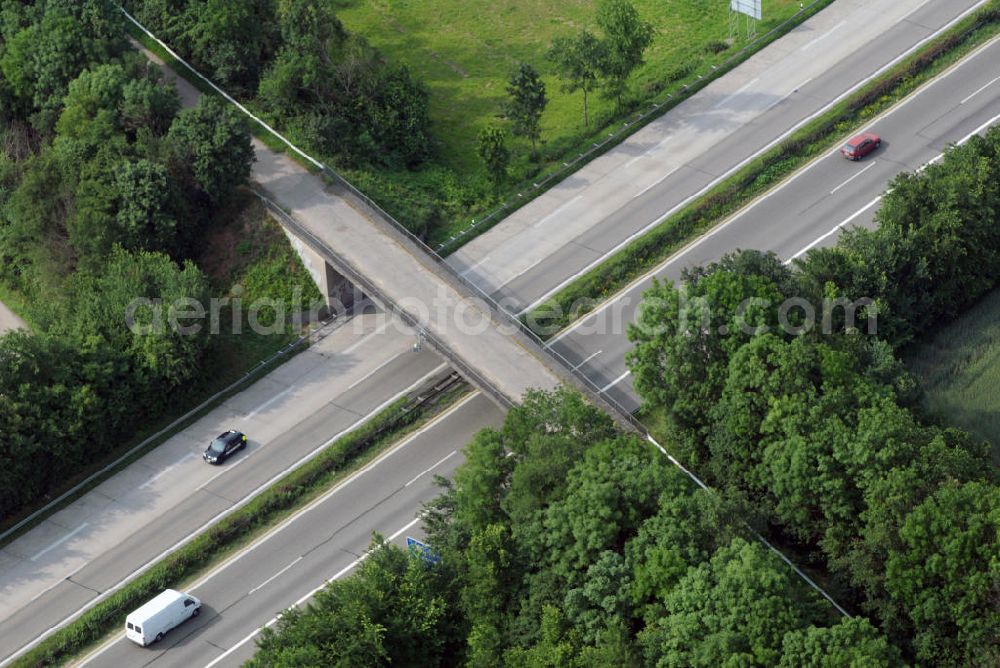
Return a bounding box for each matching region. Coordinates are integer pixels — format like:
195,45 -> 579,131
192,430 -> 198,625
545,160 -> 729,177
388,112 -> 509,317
549,34 -> 1000,410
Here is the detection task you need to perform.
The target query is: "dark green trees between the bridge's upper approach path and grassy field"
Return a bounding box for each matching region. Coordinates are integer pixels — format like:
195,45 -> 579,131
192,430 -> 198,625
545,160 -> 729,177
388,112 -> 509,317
127,0 -> 431,168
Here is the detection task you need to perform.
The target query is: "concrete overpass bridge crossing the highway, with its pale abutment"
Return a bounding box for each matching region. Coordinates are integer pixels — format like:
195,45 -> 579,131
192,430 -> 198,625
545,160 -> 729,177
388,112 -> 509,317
251,140 -> 587,407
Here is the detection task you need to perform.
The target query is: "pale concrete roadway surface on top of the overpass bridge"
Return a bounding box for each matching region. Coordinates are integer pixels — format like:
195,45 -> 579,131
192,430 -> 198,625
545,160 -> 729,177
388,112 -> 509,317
143,36 -> 568,412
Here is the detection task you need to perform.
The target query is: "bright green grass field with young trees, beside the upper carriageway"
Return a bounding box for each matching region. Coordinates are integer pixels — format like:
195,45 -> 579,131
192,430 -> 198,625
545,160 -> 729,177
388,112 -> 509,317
333,0 -> 816,245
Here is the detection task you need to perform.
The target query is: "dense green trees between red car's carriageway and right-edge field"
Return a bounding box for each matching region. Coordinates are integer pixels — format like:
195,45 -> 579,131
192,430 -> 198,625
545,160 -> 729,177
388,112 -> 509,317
628,129 -> 1000,666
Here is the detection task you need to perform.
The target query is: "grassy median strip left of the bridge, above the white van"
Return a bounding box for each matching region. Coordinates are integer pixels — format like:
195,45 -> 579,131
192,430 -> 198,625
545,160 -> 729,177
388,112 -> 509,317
13,381 -> 468,667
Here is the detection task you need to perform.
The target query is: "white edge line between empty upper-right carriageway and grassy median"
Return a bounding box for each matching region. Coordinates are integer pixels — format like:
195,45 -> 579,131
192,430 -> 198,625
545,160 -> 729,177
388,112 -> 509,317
517,0 -> 989,316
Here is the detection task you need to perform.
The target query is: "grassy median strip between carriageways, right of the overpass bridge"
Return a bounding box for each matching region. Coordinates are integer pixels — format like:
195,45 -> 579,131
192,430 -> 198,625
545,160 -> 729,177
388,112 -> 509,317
522,0 -> 1000,338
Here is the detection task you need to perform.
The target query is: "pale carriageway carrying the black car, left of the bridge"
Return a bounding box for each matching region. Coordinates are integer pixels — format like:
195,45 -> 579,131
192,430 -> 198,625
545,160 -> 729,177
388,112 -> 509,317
0,312 -> 448,657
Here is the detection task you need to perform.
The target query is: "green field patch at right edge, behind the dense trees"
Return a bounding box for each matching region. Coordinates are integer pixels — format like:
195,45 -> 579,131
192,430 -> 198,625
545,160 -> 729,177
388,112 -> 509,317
905,289 -> 1000,465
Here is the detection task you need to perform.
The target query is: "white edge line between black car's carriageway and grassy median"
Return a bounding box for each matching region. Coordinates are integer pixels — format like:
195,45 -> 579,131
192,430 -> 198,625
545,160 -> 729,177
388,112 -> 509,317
0,366 -> 448,666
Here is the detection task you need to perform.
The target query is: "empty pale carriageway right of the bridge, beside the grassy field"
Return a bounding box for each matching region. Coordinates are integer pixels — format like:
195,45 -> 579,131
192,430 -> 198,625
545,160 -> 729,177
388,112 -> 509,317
448,0 -> 981,311
